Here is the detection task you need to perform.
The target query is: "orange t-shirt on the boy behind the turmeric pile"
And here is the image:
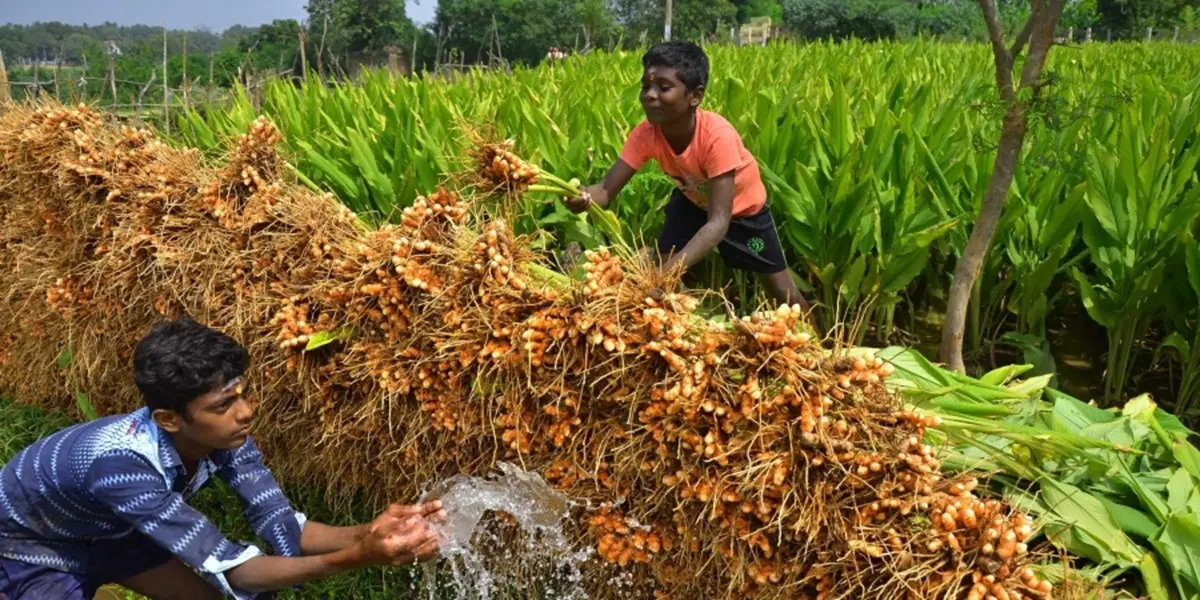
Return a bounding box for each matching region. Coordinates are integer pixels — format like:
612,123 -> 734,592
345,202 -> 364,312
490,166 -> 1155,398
620,109 -> 767,217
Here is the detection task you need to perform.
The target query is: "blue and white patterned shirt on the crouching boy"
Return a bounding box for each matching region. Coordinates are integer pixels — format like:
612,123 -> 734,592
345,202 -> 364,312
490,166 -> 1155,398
0,408 -> 305,600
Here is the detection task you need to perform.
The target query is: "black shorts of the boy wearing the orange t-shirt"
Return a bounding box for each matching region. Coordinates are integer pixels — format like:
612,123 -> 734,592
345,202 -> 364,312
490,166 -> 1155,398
659,190 -> 787,275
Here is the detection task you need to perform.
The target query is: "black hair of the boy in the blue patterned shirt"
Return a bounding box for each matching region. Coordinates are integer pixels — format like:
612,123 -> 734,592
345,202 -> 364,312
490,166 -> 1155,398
133,317 -> 250,419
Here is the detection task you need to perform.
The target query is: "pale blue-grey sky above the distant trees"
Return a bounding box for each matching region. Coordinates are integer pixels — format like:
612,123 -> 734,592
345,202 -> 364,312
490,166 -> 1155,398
0,0 -> 438,32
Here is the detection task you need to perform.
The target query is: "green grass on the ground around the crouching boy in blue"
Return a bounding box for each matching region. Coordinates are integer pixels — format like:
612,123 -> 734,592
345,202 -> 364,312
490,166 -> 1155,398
0,398 -> 419,600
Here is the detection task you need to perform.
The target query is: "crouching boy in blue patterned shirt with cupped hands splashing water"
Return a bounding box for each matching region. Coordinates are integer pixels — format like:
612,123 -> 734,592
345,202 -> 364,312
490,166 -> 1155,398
0,318 -> 445,600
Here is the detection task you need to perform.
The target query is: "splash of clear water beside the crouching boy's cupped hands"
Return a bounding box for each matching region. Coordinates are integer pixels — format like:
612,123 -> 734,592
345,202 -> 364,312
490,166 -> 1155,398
421,462 -> 592,600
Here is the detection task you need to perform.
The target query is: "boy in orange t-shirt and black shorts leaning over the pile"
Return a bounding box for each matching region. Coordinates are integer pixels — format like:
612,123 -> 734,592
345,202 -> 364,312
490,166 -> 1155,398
566,42 -> 809,311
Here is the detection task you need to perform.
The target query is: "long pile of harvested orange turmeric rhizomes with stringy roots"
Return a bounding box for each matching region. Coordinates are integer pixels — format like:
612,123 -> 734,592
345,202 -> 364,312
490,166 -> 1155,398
0,100 -> 1052,600
